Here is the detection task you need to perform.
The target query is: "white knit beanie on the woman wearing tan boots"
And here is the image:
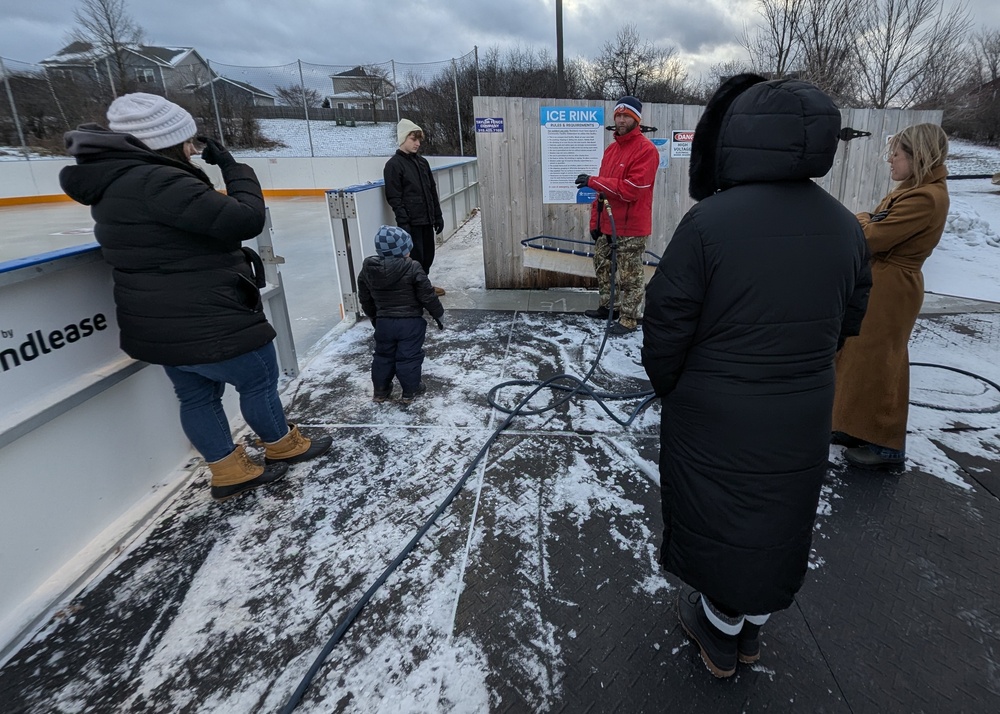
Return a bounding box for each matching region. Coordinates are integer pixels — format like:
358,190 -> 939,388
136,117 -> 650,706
108,92 -> 198,151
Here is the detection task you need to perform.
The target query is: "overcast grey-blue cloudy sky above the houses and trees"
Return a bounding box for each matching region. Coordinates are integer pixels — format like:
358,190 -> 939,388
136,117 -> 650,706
0,0 -> 1000,78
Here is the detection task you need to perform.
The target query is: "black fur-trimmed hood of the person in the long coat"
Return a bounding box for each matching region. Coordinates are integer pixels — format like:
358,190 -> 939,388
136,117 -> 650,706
689,74 -> 840,201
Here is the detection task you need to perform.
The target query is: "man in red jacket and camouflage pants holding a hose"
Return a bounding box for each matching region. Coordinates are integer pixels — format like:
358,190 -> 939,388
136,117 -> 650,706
576,97 -> 660,335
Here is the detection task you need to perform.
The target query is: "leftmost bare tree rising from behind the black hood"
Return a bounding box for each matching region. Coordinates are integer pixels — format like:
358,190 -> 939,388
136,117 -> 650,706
742,0 -> 807,79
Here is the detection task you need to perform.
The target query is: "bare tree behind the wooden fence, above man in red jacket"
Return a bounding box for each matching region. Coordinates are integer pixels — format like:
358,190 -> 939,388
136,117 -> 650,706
594,25 -> 686,99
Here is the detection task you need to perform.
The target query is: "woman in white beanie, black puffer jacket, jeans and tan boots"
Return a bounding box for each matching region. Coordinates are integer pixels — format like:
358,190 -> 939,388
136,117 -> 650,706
59,93 -> 332,500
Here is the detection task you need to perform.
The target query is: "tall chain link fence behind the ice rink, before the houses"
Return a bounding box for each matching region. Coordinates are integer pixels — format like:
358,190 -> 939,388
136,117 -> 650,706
0,48 -> 479,160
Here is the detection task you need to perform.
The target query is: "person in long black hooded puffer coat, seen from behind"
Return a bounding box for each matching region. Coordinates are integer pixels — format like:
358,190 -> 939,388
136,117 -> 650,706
642,75 -> 871,677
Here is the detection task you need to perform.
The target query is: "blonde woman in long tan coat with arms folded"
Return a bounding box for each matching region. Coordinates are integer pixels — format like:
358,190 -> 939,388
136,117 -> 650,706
831,124 -> 948,470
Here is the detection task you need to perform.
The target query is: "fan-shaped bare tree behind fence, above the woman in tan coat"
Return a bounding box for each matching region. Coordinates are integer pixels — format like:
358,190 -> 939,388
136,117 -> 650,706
855,0 -> 969,109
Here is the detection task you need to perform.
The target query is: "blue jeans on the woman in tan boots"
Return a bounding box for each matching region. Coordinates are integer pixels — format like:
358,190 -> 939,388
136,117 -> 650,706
163,342 -> 288,461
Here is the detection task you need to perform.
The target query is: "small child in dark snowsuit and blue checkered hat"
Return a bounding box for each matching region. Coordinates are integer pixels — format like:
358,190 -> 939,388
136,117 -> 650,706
358,226 -> 444,404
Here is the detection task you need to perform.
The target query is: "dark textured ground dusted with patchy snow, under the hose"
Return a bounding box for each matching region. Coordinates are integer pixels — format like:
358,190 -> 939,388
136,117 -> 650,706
0,298 -> 1000,714
